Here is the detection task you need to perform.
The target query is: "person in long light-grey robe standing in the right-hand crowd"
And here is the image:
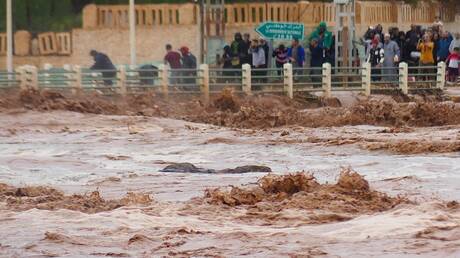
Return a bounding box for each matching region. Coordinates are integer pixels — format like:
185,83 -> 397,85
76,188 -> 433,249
383,33 -> 401,82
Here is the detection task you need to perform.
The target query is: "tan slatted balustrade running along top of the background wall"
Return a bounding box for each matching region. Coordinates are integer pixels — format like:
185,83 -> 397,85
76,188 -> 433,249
83,1 -> 455,29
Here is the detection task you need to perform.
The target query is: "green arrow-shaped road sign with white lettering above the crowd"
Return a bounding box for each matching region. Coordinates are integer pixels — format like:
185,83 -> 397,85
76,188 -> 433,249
256,22 -> 305,40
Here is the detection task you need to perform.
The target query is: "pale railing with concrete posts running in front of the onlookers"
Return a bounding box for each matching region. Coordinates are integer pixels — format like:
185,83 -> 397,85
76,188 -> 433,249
0,63 -> 452,99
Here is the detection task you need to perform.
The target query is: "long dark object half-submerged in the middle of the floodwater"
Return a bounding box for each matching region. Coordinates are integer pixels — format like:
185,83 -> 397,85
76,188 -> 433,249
160,163 -> 272,174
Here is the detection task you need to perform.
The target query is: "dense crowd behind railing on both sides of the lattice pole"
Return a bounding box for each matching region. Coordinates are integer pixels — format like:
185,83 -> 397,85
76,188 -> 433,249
222,17 -> 460,83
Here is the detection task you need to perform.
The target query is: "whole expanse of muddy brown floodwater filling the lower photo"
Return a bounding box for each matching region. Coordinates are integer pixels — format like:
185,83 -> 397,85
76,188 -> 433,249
0,109 -> 460,257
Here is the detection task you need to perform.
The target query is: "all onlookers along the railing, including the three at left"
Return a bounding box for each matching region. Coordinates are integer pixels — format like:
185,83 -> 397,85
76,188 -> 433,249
91,17 -> 460,85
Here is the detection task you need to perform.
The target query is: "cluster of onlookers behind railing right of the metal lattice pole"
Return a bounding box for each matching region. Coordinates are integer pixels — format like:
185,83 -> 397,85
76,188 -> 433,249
362,17 -> 460,83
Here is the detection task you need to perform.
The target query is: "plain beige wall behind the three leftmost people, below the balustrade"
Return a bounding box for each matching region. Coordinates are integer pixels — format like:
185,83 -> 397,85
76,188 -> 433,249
0,25 -> 199,69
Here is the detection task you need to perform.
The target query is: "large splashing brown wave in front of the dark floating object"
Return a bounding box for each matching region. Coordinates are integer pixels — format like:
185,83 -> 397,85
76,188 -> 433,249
183,169 -> 408,224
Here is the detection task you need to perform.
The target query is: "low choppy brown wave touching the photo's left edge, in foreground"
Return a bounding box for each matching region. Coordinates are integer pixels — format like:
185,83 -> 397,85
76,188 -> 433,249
0,183 -> 152,214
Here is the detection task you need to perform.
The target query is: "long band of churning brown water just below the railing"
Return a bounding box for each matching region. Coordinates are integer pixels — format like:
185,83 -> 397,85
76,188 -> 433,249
0,88 -> 460,129
